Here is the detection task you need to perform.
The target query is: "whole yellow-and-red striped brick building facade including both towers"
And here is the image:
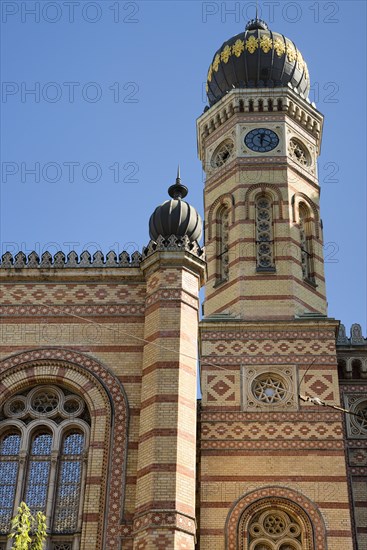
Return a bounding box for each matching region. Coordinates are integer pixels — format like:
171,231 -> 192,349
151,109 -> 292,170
0,23 -> 367,550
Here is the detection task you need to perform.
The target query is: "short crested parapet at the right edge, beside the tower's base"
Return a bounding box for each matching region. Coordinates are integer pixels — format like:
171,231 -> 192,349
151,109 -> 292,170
336,323 -> 367,380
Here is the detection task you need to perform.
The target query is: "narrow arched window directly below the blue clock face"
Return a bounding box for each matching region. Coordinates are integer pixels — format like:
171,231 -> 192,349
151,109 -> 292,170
255,195 -> 275,271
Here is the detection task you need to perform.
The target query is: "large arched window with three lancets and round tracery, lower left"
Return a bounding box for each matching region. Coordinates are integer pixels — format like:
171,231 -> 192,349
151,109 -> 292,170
0,386 -> 90,550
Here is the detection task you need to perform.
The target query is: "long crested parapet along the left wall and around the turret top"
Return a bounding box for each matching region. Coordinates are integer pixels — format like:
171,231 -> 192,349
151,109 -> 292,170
0,235 -> 205,270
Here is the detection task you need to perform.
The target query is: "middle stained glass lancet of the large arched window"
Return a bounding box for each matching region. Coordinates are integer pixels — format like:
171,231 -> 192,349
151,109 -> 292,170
24,433 -> 52,513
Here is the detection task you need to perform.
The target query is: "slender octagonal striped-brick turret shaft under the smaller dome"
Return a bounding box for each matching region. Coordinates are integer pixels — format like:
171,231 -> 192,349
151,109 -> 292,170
134,253 -> 206,550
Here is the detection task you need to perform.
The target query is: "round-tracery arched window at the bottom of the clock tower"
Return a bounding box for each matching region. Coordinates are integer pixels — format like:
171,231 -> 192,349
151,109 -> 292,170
248,510 -> 302,550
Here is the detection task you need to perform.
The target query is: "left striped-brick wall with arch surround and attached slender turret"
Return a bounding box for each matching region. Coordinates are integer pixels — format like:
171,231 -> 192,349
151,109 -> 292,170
0,248 -> 204,550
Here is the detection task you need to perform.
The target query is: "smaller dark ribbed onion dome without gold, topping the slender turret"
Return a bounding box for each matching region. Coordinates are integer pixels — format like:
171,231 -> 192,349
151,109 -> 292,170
149,168 -> 203,242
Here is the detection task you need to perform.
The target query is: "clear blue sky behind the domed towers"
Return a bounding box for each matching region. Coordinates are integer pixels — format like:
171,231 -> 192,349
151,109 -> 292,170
0,0 -> 367,333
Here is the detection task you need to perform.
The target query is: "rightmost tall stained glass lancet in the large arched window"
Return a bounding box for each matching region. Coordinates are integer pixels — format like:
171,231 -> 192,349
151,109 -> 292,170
53,433 -> 84,533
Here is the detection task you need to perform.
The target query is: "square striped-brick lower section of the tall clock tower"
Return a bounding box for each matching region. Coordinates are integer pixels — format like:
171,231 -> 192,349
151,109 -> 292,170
199,318 -> 353,550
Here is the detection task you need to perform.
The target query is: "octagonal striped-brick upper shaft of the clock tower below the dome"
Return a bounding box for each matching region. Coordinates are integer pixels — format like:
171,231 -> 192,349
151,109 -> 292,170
198,107 -> 332,319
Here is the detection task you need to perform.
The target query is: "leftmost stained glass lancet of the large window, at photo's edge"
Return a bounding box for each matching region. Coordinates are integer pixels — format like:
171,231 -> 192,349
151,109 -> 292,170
0,433 -> 20,533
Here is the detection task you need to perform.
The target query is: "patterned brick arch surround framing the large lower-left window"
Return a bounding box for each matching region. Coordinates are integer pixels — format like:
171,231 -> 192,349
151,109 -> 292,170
0,348 -> 128,550
